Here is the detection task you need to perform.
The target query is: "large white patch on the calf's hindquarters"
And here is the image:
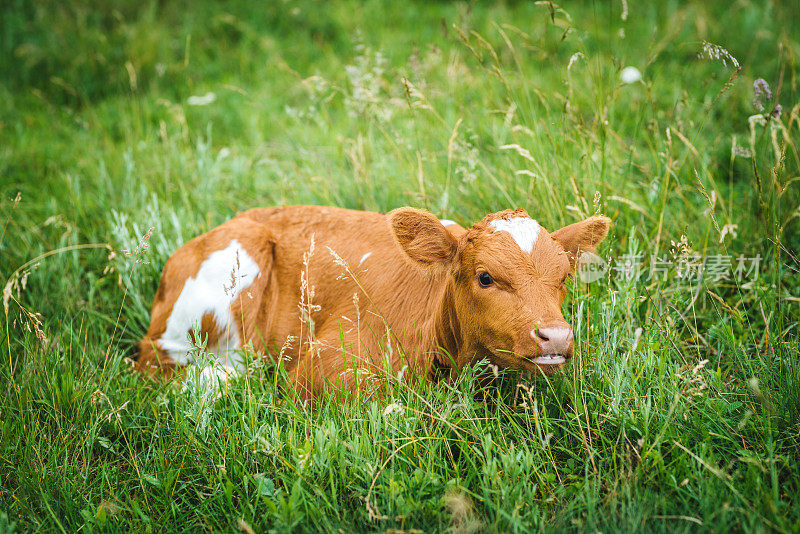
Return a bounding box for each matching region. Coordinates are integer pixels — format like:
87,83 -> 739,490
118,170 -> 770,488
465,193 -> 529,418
158,239 -> 261,366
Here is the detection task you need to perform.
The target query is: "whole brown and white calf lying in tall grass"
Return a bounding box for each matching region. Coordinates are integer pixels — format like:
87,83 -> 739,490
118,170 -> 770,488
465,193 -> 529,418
137,206 -> 610,396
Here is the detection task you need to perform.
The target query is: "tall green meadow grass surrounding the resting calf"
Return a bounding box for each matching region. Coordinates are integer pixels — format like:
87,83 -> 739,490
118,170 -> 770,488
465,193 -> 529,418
0,0 -> 800,532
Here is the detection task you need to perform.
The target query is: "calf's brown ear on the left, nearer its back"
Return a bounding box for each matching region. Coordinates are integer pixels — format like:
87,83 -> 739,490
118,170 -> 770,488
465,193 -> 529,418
386,208 -> 458,267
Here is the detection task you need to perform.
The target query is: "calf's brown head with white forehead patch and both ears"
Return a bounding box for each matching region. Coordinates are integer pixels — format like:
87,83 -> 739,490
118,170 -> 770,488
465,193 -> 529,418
389,208 -> 610,374
